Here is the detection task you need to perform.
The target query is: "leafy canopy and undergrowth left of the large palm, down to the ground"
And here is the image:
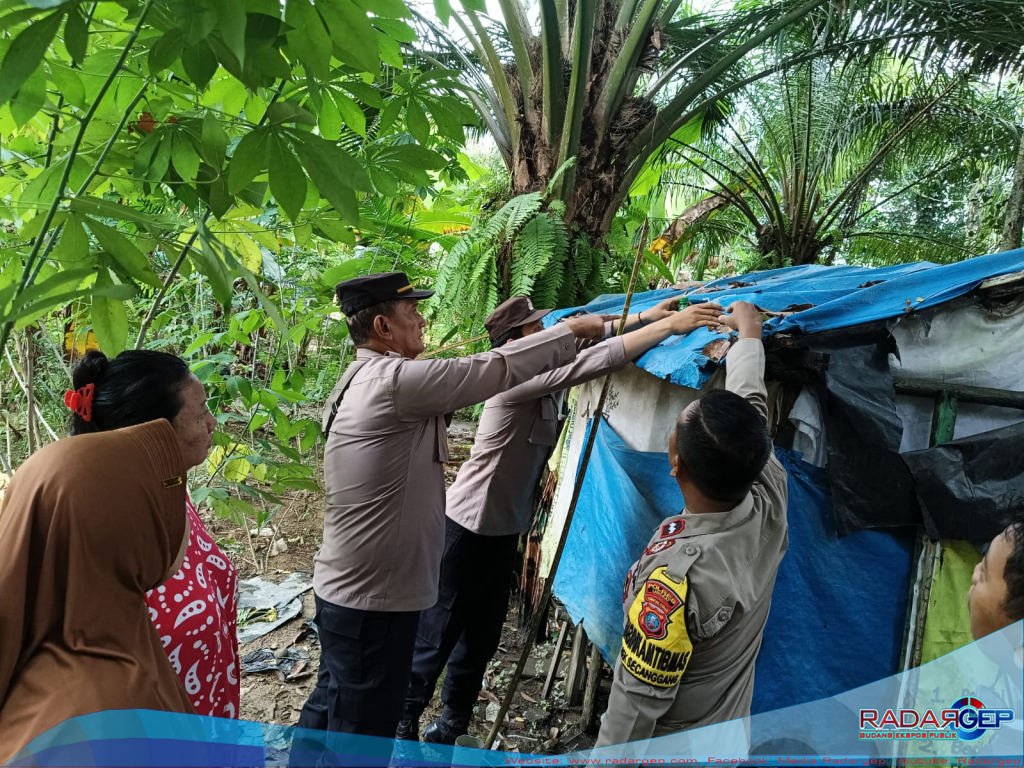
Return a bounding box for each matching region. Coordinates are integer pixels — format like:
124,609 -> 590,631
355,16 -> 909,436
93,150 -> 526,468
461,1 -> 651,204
0,0 -> 477,557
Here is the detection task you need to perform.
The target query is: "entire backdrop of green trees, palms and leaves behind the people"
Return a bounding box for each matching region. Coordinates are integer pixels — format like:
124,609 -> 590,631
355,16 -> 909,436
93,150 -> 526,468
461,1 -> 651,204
0,0 -> 1021,561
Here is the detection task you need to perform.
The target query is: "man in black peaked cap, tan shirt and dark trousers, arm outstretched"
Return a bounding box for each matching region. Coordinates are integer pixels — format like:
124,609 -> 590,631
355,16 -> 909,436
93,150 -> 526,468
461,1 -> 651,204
298,272 -> 606,738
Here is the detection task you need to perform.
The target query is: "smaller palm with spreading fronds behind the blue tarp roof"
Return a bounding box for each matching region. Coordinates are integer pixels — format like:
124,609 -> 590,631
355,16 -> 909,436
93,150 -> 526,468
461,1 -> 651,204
650,58 -> 1024,276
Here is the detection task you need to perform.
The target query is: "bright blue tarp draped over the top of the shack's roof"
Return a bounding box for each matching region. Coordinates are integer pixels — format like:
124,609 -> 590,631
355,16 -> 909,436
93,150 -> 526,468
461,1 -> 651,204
548,249 -> 1024,389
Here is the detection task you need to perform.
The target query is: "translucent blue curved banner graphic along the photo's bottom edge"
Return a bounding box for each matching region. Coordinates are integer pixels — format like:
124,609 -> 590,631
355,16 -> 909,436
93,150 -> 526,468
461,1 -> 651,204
4,626 -> 1024,768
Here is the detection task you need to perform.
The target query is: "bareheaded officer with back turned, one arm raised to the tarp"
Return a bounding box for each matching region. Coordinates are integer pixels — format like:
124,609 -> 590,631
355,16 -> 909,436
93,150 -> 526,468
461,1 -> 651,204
596,302 -> 788,746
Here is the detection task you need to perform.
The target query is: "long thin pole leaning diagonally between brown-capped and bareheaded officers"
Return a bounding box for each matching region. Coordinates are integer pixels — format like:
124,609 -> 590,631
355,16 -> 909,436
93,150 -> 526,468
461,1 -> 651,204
483,224 -> 650,750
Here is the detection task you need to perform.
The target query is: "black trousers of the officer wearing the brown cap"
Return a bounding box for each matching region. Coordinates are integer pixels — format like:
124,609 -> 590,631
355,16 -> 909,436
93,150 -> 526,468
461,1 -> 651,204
404,518 -> 519,721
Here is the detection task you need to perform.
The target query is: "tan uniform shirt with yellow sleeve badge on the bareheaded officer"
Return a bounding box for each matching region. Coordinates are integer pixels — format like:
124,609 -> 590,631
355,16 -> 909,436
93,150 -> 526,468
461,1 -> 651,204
597,339 -> 788,746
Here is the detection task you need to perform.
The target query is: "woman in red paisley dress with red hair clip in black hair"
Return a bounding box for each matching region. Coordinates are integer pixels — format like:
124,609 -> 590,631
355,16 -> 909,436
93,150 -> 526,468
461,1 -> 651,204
65,350 -> 239,718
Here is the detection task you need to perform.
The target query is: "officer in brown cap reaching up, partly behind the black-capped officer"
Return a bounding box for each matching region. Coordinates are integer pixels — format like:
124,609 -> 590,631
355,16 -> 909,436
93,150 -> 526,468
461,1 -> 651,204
398,296 -> 722,744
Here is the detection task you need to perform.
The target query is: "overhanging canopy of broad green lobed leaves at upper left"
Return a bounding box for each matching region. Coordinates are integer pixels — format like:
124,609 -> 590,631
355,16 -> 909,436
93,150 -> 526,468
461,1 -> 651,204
0,0 -> 476,348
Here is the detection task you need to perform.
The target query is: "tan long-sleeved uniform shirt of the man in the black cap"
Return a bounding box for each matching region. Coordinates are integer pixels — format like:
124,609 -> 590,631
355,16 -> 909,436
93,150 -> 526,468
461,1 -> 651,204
313,325 -> 577,611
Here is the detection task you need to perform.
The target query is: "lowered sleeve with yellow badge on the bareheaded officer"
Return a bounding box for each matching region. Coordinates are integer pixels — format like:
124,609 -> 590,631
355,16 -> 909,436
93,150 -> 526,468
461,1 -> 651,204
595,567 -> 693,746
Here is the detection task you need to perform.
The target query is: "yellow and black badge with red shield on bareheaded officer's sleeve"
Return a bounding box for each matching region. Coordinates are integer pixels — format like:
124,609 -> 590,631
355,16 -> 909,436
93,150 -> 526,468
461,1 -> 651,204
620,567 -> 693,688
